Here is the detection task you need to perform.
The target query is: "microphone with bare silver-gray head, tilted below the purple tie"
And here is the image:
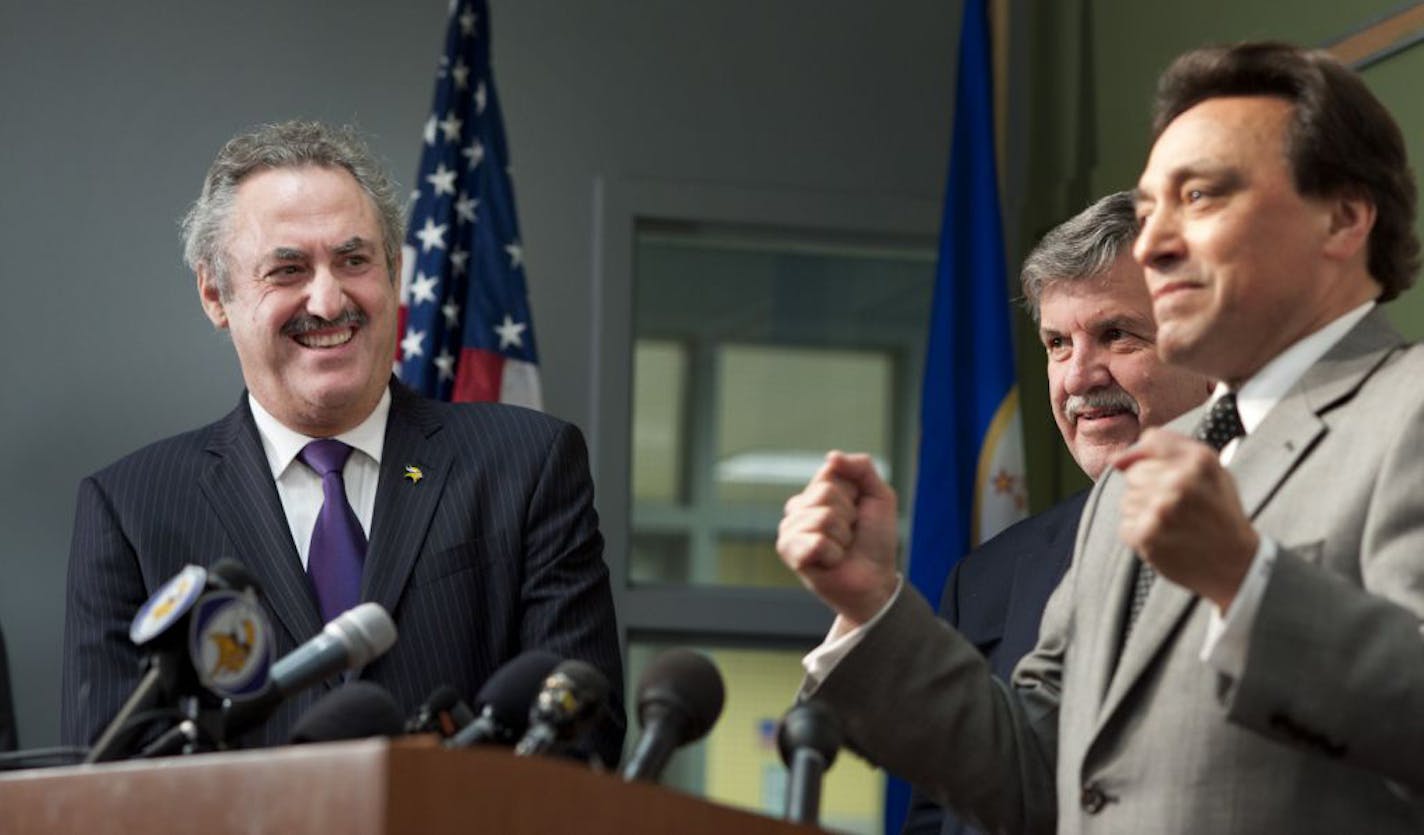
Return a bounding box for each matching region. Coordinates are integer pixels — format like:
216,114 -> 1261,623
222,603 -> 396,740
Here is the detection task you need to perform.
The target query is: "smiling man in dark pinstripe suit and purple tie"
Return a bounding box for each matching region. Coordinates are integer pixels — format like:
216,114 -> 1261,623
61,123 -> 624,762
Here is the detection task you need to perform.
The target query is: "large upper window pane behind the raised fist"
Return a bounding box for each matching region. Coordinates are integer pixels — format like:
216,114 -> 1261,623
628,222 -> 934,587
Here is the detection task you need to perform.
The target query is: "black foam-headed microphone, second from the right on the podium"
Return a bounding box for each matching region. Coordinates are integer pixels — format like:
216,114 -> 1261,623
622,650 -> 725,782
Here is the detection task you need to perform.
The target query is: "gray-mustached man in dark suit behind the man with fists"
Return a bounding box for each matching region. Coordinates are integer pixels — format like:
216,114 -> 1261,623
904,191 -> 1212,835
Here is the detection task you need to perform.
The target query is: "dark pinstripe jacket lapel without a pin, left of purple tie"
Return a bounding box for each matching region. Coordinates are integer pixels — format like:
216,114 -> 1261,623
199,395 -> 322,643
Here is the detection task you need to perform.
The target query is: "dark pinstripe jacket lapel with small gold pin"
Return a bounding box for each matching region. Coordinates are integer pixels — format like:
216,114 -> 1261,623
362,383 -> 453,613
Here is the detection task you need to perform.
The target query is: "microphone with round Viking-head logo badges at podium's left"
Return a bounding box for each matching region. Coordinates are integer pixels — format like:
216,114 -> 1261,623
84,557 -> 271,762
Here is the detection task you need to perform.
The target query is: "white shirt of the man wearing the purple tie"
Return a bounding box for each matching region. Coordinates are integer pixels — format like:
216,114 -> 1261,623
248,388 -> 390,569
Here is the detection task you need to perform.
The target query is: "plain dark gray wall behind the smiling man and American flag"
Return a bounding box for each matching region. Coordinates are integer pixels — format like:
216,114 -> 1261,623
0,0 -> 958,747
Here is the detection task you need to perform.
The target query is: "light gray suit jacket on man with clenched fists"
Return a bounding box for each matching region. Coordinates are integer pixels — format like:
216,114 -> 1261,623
816,311 -> 1424,835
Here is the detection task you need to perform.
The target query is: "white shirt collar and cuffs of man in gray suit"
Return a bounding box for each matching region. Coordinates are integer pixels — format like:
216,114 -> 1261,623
802,301 -> 1374,688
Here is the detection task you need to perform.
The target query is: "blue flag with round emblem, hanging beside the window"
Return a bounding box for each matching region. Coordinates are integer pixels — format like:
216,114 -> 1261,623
886,0 -> 1028,832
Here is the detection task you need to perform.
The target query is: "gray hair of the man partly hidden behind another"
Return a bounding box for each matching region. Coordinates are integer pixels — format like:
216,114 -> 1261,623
1020,191 -> 1138,322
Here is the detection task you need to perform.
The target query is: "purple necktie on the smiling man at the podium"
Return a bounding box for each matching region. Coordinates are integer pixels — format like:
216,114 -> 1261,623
296,439 -> 366,621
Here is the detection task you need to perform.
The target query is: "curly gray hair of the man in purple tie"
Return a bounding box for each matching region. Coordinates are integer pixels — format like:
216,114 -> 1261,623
182,121 -> 406,299
